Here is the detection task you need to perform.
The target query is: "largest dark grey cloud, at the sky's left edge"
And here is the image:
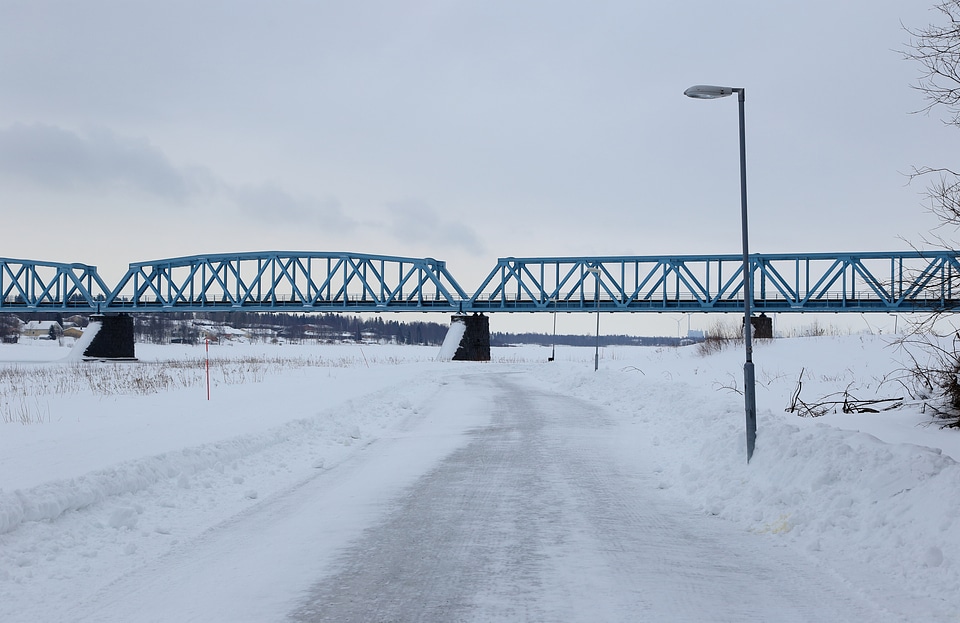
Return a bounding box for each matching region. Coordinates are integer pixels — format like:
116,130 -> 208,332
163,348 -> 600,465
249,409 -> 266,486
0,124 -> 206,202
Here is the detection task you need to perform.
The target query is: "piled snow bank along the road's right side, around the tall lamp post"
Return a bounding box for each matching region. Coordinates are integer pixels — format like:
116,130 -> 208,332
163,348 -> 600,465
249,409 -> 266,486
537,338 -> 960,603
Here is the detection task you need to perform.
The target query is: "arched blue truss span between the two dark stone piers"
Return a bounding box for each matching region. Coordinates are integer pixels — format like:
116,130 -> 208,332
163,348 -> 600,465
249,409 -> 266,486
101,251 -> 466,311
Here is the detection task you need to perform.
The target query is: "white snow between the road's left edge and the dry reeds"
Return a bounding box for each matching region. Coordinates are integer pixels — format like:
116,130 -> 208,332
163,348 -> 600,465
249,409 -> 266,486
0,347 -> 474,622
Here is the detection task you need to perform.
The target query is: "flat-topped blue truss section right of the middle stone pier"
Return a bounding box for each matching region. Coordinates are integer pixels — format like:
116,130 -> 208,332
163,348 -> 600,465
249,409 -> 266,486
467,251 -> 960,312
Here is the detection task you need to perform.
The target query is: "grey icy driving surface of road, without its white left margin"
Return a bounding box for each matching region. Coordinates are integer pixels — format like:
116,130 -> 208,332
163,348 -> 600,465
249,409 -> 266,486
292,375 -> 883,622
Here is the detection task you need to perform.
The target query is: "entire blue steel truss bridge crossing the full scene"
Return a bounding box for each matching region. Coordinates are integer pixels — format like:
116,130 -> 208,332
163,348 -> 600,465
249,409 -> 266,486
0,251 -> 960,313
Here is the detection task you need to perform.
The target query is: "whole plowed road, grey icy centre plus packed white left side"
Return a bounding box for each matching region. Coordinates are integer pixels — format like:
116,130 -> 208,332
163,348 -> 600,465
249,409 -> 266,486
73,373 -> 900,623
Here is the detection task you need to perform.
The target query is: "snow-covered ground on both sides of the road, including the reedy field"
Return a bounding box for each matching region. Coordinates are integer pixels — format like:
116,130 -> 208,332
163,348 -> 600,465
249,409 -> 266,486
0,335 -> 960,622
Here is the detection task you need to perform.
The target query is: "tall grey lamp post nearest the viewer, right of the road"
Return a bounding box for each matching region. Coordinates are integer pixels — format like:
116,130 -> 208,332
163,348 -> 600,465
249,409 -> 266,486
683,84 -> 757,463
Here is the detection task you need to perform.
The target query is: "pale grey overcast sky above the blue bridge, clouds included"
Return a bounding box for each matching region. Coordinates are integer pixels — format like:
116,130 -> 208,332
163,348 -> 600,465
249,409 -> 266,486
0,0 -> 960,336
